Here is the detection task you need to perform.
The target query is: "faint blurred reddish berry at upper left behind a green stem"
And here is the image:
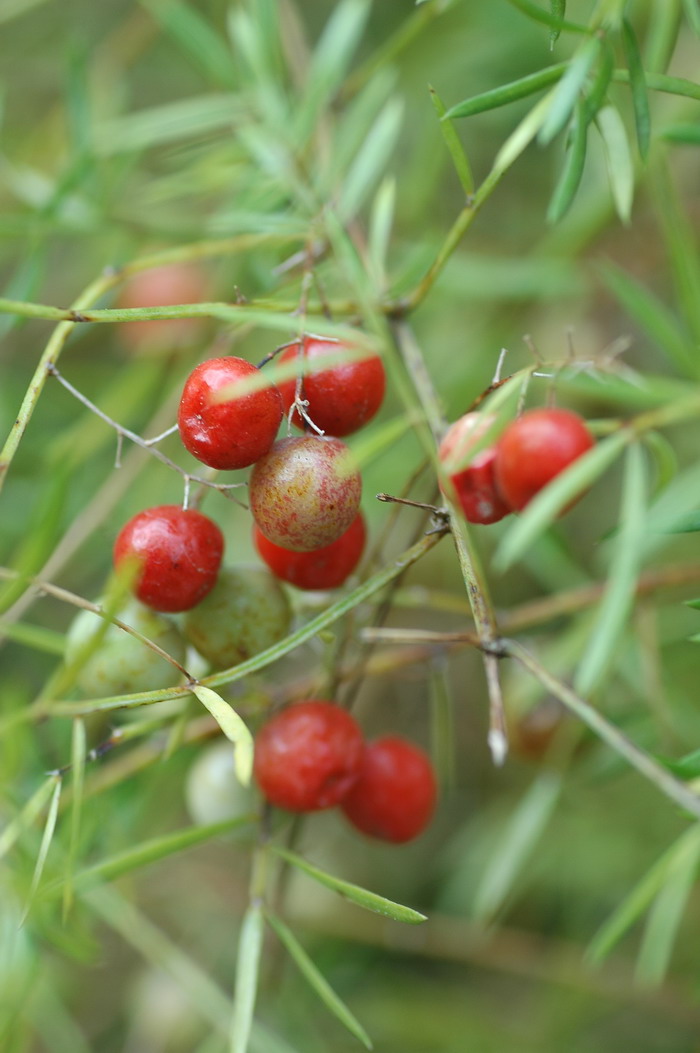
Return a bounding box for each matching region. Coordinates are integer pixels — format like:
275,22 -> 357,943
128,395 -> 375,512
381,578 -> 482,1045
117,263 -> 208,351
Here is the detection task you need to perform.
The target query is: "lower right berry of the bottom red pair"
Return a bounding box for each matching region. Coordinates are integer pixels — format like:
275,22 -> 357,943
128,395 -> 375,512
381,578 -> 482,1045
341,735 -> 438,843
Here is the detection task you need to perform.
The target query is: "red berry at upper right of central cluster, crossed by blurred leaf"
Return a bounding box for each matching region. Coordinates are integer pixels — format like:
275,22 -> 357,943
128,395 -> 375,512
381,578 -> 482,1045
279,337 -> 386,436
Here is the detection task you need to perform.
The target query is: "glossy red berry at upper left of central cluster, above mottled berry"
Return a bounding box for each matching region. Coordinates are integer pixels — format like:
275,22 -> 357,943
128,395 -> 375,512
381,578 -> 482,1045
178,355 -> 282,470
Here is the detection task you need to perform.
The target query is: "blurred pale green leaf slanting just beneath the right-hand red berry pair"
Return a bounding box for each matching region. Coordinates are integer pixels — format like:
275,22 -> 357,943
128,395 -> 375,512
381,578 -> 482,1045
494,432 -> 629,571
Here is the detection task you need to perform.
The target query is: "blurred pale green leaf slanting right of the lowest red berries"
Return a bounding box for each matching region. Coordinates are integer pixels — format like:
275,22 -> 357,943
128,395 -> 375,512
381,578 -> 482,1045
474,772 -> 561,921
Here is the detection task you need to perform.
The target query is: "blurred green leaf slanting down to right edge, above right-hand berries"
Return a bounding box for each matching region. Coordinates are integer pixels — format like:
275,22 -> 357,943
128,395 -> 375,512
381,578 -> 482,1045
598,263 -> 698,377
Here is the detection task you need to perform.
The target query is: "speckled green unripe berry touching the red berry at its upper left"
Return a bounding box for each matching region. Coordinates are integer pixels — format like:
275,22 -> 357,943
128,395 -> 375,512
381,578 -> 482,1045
184,567 -> 292,669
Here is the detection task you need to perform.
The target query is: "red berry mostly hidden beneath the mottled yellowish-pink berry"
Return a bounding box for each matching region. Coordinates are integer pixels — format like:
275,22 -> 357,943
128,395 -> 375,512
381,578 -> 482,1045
253,513 -> 366,589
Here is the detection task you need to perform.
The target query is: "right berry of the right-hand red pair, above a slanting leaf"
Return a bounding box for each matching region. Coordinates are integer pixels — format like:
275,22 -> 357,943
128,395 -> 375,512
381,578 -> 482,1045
496,410 -> 594,511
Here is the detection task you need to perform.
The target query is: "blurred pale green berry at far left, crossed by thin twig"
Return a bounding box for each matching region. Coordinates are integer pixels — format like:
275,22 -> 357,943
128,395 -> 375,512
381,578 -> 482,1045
65,600 -> 186,698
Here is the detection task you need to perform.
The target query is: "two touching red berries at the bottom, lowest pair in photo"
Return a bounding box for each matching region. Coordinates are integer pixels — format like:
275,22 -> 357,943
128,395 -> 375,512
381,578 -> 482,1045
255,699 -> 437,843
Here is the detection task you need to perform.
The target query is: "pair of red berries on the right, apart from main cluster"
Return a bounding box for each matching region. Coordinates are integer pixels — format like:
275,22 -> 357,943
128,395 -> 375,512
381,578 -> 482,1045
438,409 -> 594,523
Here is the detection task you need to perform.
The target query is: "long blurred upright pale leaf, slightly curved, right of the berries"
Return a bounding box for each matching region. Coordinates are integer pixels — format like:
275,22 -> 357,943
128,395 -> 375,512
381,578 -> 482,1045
574,443 -> 646,696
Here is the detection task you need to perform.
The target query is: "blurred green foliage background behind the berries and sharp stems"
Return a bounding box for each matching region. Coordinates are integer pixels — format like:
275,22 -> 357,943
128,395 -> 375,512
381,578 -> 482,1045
0,0 -> 700,1053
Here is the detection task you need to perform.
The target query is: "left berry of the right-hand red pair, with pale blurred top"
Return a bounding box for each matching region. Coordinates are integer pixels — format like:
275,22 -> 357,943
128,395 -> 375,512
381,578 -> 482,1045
438,413 -> 511,523
